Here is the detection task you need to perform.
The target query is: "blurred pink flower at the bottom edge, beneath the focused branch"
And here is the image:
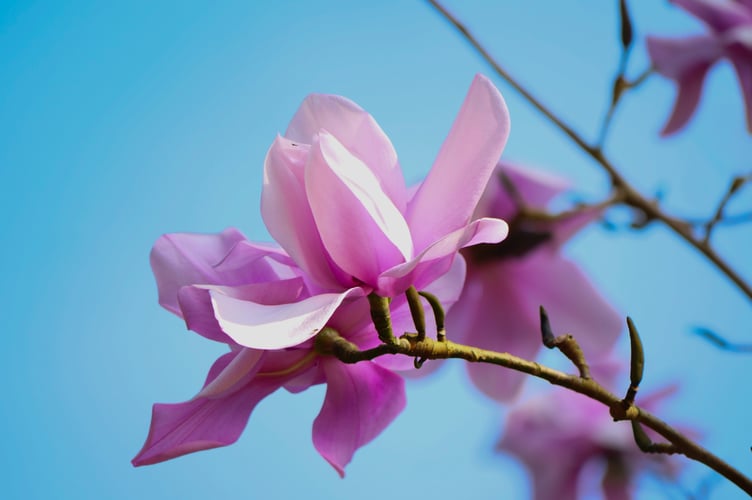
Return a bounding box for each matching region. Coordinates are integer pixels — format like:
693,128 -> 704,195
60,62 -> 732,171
497,364 -> 678,500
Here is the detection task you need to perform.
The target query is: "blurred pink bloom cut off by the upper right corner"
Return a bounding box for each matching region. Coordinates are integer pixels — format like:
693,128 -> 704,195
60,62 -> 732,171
647,0 -> 752,135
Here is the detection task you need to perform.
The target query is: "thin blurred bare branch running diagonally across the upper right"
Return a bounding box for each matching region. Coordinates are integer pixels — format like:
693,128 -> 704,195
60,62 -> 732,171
428,0 -> 752,301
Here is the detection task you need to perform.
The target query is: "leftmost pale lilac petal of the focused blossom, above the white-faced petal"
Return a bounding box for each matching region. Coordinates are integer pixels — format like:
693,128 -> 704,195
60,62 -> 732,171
150,228 -> 245,315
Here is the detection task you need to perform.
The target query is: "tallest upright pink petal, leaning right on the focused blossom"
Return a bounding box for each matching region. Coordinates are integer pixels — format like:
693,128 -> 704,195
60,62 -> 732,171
408,75 -> 510,250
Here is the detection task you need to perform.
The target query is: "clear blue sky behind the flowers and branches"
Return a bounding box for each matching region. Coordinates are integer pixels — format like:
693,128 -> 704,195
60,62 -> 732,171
0,0 -> 752,499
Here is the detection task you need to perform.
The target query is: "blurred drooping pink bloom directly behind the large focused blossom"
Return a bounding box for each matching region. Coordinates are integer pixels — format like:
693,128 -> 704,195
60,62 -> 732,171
447,162 -> 623,400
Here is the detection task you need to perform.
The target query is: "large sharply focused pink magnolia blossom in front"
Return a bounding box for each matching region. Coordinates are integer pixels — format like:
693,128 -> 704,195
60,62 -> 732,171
133,76 -> 509,474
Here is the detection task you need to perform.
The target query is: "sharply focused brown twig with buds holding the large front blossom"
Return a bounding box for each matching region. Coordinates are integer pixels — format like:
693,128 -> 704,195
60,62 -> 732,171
315,316 -> 752,495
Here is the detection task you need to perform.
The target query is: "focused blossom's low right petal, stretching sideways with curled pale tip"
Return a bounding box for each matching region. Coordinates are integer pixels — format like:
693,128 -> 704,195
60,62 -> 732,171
378,219 -> 509,297
